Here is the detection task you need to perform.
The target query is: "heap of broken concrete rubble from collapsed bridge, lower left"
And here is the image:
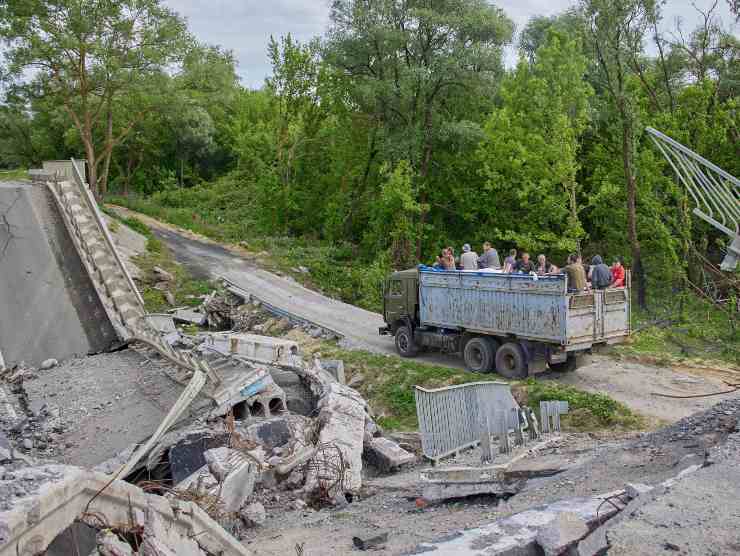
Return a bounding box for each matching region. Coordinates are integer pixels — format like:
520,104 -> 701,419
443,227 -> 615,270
0,280 -> 416,556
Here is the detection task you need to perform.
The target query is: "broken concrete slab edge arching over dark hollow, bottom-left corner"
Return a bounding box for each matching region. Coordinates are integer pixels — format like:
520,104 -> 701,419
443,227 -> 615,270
0,465 -> 250,556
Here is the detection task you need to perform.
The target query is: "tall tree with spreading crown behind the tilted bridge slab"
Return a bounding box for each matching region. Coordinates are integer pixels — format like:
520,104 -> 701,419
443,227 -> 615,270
0,0 -> 189,193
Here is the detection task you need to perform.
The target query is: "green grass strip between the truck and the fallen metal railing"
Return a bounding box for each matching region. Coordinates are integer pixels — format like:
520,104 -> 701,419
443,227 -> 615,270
304,343 -> 645,431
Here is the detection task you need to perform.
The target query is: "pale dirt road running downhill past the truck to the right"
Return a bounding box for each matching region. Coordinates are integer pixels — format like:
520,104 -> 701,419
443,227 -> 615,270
107,207 -> 740,423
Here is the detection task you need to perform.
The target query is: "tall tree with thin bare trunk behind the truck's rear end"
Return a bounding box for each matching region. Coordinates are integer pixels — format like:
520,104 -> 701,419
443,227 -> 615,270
581,0 -> 658,307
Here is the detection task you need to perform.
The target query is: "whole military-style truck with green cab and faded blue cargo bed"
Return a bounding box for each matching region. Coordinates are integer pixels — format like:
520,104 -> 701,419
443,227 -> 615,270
380,268 -> 630,378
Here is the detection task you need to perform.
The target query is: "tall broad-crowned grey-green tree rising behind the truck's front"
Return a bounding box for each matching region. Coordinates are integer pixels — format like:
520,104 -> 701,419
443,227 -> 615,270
326,0 -> 513,257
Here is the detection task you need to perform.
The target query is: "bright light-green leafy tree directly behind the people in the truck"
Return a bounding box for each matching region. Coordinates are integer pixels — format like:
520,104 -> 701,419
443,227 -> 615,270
478,29 -> 593,254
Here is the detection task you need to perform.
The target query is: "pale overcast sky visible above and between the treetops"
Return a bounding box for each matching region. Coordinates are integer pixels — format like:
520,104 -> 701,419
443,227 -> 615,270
165,0 -> 737,87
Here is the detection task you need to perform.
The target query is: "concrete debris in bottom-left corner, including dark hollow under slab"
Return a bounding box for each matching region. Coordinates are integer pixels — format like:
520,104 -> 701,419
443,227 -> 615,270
0,465 -> 250,556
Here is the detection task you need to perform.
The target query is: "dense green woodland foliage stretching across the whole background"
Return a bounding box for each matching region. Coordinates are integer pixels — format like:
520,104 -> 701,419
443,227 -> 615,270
0,0 -> 740,306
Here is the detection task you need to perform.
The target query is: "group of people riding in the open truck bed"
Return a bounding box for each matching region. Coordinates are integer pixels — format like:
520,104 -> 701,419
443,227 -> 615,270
433,241 -> 625,292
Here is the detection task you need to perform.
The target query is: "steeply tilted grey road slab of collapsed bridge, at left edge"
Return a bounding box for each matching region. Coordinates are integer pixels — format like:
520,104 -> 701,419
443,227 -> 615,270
0,182 -> 117,366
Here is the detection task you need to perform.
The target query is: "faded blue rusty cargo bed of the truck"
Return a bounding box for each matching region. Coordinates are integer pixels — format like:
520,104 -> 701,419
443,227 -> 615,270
419,270 -> 630,350
